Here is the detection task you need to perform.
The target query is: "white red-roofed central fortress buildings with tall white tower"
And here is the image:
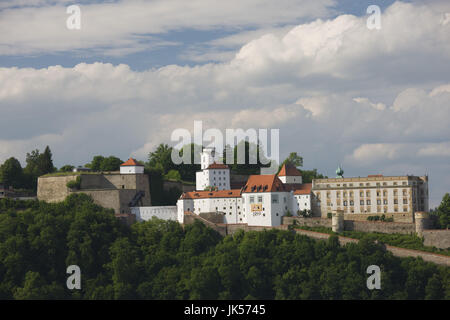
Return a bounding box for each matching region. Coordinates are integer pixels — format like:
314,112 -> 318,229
177,149 -> 312,226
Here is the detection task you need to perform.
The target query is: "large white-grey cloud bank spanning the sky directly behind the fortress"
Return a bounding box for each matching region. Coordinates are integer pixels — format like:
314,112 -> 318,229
0,1 -> 450,206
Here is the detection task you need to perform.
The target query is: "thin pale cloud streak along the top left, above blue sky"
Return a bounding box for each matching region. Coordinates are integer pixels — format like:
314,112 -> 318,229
0,0 -> 334,55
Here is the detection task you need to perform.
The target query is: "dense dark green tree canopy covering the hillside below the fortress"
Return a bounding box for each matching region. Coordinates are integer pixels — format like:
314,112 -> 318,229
0,194 -> 450,299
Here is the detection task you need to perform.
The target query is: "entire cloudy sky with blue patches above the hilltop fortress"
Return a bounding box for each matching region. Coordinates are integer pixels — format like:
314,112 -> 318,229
0,0 -> 450,205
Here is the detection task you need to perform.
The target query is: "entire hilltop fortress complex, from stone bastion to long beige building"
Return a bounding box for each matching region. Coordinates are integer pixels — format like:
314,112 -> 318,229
38,148 -> 429,227
